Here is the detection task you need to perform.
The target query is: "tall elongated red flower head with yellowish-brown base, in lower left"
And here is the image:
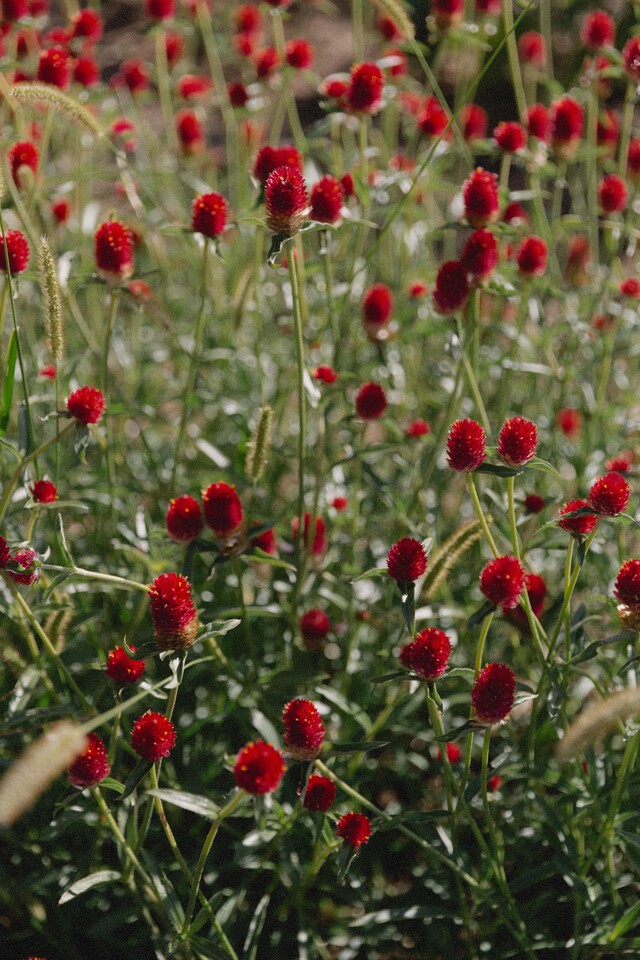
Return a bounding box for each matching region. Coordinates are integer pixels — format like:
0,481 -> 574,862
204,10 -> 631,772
148,573 -> 199,650
